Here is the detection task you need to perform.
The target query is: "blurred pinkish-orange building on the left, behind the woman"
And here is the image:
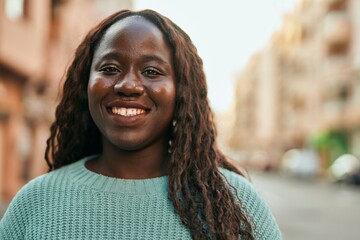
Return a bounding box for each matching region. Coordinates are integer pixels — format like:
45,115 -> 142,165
0,0 -> 132,202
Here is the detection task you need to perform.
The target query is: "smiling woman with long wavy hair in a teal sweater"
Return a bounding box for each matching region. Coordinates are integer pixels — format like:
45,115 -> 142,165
0,10 -> 280,240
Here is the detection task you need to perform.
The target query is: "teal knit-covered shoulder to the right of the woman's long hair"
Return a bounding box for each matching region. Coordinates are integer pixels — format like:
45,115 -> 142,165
220,168 -> 281,240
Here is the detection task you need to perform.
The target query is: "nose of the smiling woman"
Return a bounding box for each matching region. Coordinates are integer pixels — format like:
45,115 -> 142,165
114,71 -> 144,96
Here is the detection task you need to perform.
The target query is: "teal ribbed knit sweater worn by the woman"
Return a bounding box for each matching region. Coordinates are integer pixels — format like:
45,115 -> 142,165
0,158 -> 281,240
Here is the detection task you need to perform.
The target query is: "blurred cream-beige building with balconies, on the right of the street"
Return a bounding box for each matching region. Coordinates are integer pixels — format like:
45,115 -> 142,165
228,0 -> 360,172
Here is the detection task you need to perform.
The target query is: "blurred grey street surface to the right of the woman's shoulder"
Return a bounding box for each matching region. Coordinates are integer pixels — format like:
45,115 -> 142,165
250,172 -> 360,240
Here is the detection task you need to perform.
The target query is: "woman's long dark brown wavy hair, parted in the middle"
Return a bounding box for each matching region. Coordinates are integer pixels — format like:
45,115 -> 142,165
45,10 -> 253,239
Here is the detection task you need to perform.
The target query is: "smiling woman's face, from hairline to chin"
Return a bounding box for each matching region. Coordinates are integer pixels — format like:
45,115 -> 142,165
88,16 -> 175,151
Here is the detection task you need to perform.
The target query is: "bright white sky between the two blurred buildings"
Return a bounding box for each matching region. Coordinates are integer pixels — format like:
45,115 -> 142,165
134,0 -> 299,112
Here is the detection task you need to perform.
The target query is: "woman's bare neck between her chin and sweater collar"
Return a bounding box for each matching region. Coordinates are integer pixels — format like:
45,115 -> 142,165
86,141 -> 170,179
